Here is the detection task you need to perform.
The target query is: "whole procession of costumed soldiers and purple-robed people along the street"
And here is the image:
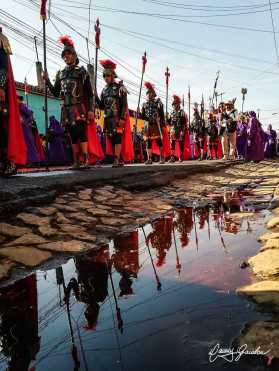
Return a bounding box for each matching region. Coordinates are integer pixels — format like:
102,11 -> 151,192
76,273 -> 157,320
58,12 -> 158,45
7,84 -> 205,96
0,30 -> 277,175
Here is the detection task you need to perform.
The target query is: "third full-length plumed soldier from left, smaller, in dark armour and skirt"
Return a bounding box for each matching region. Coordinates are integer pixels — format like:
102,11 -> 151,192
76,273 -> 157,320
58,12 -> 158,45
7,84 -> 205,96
142,82 -> 165,165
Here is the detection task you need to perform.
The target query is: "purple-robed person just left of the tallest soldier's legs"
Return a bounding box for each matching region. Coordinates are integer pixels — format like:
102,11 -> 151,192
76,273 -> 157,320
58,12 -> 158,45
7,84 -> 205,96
48,116 -> 68,165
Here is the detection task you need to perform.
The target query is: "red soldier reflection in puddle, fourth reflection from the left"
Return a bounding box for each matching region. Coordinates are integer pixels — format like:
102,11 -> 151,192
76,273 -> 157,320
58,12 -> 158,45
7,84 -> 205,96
147,217 -> 172,267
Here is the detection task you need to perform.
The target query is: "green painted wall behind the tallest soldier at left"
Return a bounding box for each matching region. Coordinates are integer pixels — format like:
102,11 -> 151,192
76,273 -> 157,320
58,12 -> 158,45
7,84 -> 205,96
18,90 -> 61,134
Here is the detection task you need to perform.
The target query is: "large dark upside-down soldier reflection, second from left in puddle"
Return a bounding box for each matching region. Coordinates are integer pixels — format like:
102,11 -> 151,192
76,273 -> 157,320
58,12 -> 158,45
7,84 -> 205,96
65,246 -> 109,329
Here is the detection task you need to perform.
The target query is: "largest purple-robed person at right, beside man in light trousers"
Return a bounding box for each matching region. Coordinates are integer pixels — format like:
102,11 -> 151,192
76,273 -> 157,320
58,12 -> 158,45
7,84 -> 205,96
247,111 -> 266,162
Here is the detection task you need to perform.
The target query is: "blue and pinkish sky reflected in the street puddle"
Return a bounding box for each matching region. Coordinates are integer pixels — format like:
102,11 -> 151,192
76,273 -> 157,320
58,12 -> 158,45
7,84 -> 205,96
24,211 -> 270,371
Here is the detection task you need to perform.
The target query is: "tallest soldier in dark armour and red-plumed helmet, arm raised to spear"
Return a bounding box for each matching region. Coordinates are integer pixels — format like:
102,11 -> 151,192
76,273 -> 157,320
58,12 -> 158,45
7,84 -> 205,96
44,36 -> 94,169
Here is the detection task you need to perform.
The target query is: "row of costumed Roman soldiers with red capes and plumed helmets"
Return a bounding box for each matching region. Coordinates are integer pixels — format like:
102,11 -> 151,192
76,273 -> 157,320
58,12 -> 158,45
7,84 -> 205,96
0,29 -> 272,175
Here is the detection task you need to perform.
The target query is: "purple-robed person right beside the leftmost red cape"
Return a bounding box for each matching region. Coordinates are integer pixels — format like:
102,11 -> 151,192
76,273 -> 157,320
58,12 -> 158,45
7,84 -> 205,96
18,96 -> 40,165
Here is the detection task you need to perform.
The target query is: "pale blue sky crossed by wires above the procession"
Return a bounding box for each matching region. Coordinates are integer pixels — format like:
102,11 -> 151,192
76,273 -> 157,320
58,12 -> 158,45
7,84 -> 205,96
0,0 -> 279,130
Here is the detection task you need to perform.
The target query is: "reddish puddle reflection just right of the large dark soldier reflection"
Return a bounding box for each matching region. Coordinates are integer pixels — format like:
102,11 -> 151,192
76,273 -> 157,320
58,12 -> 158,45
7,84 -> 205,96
112,231 -> 139,296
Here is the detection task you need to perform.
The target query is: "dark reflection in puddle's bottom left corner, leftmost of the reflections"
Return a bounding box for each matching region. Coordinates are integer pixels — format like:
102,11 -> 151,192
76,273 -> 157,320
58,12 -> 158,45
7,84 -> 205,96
0,274 -> 40,371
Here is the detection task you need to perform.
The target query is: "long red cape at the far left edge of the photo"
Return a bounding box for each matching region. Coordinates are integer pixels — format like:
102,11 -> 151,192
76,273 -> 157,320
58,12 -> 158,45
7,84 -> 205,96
7,57 -> 27,165
